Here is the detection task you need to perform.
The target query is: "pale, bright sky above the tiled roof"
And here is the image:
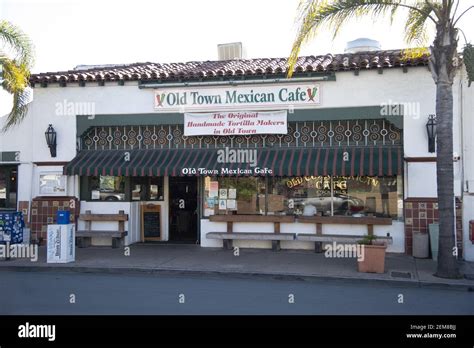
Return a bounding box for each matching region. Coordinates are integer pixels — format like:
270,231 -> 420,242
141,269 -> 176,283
0,0 -> 474,115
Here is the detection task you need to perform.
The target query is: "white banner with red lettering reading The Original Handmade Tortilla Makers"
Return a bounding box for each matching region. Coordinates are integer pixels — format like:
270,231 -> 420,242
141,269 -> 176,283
184,110 -> 288,136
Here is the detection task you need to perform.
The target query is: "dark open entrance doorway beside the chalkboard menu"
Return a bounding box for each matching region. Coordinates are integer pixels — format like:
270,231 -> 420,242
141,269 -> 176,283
169,177 -> 198,243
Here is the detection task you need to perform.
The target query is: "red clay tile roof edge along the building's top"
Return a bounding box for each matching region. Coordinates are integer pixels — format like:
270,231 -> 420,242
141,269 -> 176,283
30,50 -> 429,85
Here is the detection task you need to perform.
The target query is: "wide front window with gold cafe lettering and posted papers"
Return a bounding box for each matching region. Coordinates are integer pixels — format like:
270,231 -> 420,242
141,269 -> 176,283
203,176 -> 403,219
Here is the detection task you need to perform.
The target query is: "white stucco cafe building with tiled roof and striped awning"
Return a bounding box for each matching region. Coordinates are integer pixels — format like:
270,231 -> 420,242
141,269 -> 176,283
0,51 -> 470,260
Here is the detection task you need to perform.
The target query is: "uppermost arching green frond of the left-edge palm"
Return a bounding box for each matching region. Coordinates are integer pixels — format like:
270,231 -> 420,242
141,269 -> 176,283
0,20 -> 34,68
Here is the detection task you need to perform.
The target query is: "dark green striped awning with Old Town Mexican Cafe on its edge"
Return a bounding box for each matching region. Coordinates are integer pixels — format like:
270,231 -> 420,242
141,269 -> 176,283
64,146 -> 403,176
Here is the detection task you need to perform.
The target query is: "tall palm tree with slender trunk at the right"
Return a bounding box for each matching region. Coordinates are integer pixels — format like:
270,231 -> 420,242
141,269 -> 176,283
288,0 -> 474,278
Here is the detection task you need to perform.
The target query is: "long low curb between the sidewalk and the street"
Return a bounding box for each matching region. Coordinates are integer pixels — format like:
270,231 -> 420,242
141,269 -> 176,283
0,266 -> 474,292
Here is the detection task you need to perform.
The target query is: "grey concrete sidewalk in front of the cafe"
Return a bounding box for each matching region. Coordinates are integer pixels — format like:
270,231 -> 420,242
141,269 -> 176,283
0,244 -> 474,289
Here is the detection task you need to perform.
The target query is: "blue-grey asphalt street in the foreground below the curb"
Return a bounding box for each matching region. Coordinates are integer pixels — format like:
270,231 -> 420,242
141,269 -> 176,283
0,270 -> 474,315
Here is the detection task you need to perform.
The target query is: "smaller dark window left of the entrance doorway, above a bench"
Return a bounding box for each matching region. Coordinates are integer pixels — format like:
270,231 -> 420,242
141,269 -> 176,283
81,176 -> 164,201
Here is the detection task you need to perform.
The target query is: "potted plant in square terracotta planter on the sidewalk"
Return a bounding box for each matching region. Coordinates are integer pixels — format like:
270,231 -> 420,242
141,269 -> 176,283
357,235 -> 387,273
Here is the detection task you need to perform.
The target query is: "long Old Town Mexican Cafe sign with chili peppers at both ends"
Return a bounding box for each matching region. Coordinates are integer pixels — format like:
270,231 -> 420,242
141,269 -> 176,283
154,83 -> 321,112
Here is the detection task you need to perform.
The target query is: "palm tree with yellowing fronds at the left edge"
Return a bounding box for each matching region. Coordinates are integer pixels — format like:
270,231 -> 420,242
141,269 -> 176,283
0,20 -> 33,131
